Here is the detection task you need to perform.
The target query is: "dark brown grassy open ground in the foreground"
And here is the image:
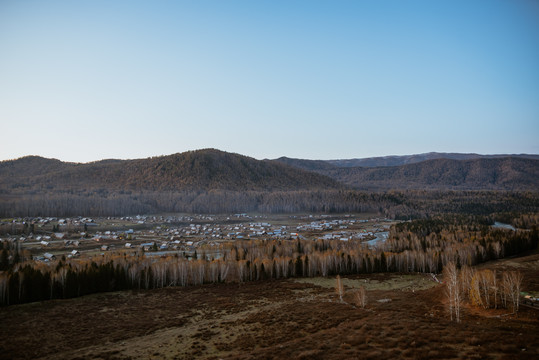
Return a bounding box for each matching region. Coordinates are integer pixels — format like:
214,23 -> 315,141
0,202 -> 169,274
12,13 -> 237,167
0,254 -> 539,359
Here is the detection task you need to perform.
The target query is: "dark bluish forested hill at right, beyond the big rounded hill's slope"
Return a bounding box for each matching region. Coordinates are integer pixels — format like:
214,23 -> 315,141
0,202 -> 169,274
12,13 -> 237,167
318,157 -> 539,191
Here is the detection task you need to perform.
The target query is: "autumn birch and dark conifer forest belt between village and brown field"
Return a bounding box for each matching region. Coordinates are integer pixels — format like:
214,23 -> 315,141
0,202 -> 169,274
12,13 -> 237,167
0,215 -> 539,306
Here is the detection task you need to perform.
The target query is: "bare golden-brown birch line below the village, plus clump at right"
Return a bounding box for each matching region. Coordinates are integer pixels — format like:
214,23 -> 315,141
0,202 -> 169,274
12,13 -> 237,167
0,215 -> 537,306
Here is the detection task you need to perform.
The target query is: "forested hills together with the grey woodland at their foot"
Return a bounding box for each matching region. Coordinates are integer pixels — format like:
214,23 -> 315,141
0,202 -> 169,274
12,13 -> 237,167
0,149 -> 539,218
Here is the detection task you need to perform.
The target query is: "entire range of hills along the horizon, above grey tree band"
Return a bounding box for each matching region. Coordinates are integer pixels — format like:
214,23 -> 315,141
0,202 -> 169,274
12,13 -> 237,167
0,149 -> 539,195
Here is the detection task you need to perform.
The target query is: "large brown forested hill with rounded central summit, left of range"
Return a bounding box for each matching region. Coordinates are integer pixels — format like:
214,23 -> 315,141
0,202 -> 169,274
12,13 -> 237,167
0,149 -> 342,194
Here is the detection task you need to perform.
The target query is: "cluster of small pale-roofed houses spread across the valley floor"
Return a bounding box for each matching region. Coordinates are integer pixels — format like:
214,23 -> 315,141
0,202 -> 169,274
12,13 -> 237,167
3,214 -> 392,261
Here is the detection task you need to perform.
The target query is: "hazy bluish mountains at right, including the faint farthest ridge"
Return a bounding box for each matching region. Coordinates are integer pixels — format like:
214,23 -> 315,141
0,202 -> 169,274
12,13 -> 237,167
276,153 -> 539,191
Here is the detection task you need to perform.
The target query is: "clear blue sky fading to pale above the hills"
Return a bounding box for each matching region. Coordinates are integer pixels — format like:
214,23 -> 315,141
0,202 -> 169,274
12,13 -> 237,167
0,0 -> 539,162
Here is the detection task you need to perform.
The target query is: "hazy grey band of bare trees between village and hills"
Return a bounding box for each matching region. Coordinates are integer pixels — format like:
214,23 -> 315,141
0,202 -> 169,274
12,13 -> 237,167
0,188 -> 538,219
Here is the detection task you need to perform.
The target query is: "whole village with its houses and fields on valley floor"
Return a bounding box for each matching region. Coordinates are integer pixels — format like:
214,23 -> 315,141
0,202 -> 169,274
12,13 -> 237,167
0,214 -> 394,263
